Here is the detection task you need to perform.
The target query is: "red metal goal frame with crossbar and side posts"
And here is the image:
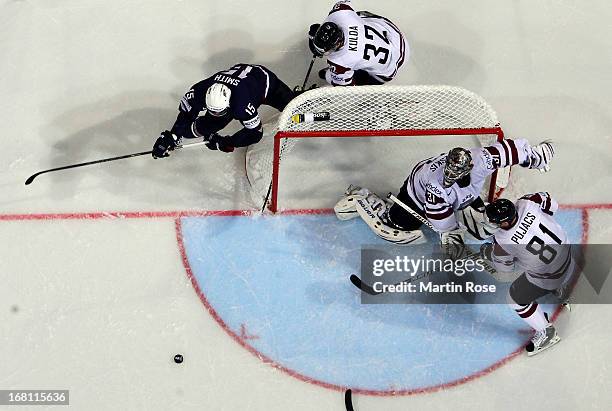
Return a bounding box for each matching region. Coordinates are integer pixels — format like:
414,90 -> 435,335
269,126 -> 504,213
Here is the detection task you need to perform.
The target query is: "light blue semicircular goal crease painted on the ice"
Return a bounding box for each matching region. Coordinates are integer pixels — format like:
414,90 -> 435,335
181,210 -> 582,390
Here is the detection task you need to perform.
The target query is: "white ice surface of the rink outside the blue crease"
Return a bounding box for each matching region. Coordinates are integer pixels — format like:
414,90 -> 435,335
0,0 -> 612,410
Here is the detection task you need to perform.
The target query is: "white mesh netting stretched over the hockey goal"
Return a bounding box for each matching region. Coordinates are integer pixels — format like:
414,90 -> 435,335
246,86 -> 507,212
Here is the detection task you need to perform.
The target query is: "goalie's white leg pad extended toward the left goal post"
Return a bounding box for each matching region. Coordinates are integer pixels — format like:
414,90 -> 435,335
354,193 -> 426,244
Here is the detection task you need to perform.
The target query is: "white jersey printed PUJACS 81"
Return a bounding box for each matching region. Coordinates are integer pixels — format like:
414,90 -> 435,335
492,192 -> 574,290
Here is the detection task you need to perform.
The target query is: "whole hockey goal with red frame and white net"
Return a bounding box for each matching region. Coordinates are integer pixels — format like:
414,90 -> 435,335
246,86 -> 509,212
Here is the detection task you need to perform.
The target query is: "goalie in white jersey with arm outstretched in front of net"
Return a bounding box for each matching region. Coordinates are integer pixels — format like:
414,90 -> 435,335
334,139 -> 554,249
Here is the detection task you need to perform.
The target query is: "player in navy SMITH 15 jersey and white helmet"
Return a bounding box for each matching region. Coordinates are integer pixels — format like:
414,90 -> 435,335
152,63 -> 295,158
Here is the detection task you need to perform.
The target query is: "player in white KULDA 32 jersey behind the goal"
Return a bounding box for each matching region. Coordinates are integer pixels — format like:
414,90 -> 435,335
308,0 -> 409,86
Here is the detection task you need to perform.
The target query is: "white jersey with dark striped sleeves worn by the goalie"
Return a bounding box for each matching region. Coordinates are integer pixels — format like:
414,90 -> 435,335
406,139 -> 531,232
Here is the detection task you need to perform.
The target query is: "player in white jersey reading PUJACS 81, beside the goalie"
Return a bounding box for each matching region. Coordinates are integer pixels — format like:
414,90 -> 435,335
481,192 -> 576,356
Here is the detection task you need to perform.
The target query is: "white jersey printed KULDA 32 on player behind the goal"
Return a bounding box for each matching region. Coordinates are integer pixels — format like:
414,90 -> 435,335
325,1 -> 409,86
